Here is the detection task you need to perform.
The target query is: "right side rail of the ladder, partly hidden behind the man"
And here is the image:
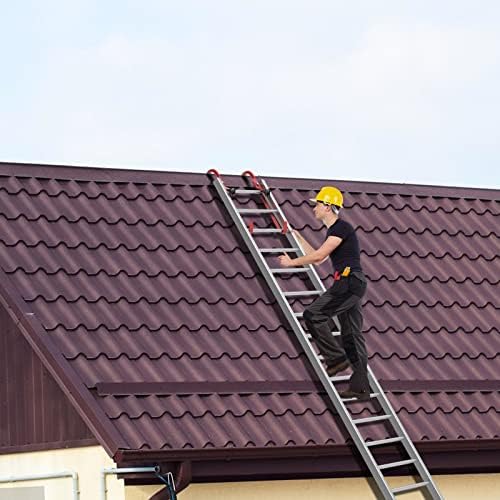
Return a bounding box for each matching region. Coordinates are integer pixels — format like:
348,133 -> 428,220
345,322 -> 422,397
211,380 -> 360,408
260,179 -> 443,500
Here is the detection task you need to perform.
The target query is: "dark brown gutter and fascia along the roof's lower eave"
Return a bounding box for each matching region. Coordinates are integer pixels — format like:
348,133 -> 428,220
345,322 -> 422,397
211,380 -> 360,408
115,439 -> 500,484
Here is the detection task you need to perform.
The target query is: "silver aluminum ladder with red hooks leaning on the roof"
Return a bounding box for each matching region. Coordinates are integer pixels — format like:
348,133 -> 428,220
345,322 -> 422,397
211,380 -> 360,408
207,169 -> 443,500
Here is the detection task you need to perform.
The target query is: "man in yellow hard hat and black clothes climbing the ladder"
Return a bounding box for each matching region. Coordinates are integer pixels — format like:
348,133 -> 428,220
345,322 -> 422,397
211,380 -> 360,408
280,186 -> 370,400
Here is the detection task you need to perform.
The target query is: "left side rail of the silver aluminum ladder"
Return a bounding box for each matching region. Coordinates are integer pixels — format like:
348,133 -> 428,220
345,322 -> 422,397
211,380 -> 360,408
213,178 -> 395,500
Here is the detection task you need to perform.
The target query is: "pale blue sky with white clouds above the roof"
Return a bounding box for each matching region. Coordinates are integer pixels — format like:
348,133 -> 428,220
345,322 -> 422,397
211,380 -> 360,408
0,0 -> 500,188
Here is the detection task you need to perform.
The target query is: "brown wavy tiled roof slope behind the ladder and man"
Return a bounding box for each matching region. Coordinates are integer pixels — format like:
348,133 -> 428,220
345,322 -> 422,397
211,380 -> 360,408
0,163 -> 500,472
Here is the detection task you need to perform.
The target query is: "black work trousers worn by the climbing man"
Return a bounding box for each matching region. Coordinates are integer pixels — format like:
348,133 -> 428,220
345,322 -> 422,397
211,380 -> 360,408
304,272 -> 370,392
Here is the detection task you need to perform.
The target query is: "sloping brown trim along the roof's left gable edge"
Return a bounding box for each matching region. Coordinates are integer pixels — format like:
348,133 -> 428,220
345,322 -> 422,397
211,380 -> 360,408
0,267 -> 126,457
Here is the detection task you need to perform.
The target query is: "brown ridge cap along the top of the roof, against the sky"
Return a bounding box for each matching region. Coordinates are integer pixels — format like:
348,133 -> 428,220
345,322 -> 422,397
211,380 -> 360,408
0,162 -> 500,200
